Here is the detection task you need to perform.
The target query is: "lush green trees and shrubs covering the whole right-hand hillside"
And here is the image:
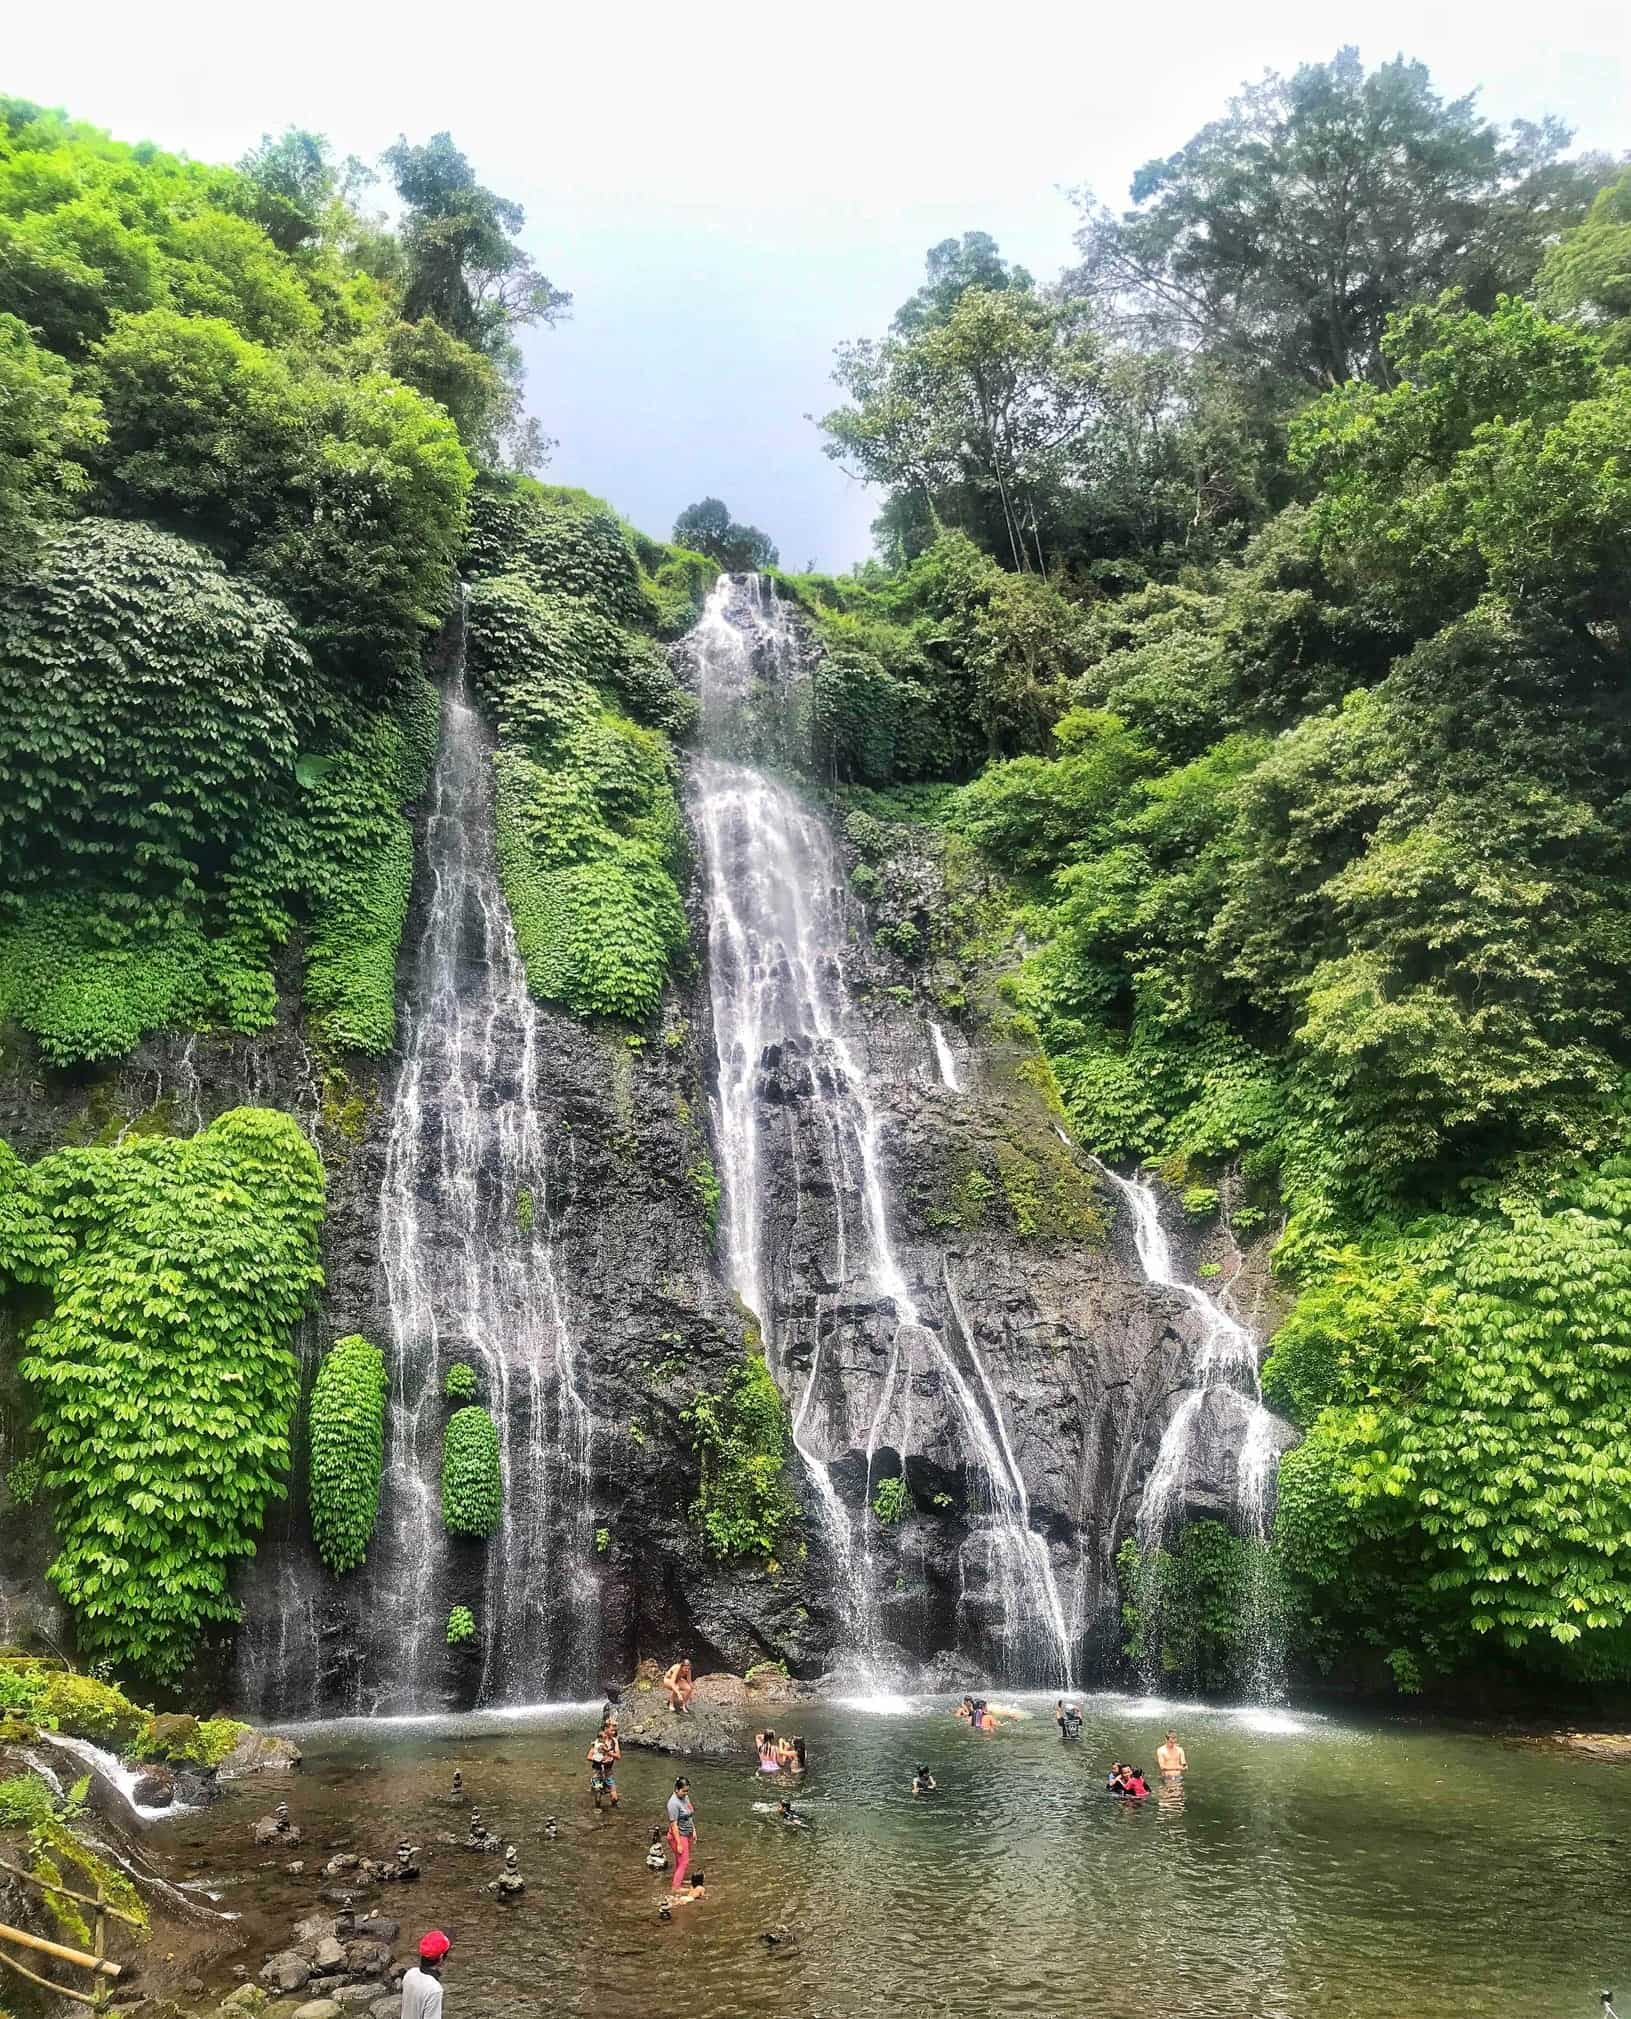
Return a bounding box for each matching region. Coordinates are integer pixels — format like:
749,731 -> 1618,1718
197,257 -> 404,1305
807,52 -> 1631,1686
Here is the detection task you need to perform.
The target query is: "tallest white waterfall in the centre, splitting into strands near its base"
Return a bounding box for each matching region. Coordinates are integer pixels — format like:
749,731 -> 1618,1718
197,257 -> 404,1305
688,575 -> 1072,1682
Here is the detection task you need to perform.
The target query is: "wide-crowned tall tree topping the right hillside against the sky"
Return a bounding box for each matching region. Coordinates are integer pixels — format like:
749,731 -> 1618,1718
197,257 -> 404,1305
1072,48 -> 1611,386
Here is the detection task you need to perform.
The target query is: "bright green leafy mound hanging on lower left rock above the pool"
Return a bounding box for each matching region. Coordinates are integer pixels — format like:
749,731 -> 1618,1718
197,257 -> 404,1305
0,1108 -> 323,1680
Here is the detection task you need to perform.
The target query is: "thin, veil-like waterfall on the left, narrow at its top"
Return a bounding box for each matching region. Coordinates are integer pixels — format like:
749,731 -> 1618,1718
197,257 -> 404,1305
359,605 -> 597,1708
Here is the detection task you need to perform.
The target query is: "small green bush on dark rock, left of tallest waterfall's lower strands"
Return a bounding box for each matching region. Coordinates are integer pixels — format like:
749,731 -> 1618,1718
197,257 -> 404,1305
684,1351 -> 797,1557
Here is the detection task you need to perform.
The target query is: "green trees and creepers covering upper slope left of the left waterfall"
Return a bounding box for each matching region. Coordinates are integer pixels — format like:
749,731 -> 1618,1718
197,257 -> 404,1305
0,99 -> 577,1066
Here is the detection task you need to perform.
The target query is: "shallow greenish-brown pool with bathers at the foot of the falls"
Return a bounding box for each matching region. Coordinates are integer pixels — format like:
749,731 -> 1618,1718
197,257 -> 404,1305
149,1696 -> 1631,2019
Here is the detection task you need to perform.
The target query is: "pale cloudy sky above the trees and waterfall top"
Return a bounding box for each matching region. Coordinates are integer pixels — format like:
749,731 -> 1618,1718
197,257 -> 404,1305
0,0 -> 1631,567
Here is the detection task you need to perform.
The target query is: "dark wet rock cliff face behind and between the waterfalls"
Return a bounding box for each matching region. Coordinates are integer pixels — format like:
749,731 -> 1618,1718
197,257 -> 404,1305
0,625 -> 1262,1704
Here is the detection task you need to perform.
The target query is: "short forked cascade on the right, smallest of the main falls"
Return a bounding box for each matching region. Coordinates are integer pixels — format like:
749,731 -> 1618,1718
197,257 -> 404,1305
1098,1165 -> 1284,1698
